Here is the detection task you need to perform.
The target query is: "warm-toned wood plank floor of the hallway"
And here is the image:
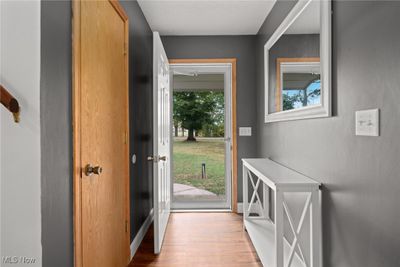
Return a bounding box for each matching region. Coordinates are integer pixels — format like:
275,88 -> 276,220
129,213 -> 262,267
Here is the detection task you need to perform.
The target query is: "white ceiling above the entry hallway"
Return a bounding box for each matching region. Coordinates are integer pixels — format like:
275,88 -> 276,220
138,0 -> 275,35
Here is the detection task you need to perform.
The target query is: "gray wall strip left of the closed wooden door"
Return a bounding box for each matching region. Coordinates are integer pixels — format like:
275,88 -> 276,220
40,1 -> 73,267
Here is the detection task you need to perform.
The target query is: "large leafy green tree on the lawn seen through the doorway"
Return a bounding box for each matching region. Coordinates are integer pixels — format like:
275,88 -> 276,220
173,92 -> 216,141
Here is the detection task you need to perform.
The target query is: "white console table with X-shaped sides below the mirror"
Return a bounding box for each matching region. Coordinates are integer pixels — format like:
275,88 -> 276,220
242,158 -> 321,267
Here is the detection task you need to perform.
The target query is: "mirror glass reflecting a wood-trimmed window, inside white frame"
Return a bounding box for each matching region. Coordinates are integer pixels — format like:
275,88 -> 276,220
268,0 -> 322,113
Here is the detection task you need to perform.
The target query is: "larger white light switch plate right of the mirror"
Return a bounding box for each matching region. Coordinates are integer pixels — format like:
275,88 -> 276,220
356,109 -> 379,136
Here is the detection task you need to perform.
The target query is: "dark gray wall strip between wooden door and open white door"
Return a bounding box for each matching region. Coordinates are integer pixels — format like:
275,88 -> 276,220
121,1 -> 153,241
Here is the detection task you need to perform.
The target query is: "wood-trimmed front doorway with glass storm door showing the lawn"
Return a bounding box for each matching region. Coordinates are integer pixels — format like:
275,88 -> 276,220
170,59 -> 237,211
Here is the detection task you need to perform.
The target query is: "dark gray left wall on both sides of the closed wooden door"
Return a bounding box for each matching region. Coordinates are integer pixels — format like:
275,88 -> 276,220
40,1 -> 153,267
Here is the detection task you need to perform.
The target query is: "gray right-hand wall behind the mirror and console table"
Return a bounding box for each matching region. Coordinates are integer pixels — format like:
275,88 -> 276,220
257,1 -> 400,267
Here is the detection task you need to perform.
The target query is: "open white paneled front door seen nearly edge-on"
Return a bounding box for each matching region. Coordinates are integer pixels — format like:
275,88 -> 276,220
152,32 -> 171,254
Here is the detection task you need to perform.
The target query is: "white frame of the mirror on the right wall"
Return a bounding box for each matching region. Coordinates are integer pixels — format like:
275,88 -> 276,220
264,0 -> 332,123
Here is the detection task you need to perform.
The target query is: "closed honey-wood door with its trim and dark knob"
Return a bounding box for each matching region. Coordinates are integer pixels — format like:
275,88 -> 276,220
73,0 -> 130,267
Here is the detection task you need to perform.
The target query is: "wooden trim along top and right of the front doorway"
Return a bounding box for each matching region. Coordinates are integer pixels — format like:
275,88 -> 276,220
169,58 -> 238,213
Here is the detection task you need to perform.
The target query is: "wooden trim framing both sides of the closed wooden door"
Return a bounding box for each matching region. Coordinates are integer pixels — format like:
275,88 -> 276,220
71,0 -> 130,267
